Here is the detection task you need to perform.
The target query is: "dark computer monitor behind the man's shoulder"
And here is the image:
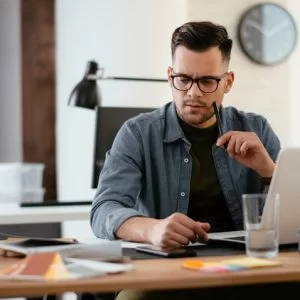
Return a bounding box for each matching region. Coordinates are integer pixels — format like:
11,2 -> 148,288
92,106 -> 154,188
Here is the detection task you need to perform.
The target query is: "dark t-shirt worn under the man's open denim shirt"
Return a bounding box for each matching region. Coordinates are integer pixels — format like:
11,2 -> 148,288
178,118 -> 234,232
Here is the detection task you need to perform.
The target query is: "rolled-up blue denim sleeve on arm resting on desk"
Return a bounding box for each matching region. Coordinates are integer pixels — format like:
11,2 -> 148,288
90,120 -> 147,239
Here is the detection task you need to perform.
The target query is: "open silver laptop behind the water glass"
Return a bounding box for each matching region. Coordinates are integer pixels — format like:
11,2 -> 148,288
208,147 -> 300,245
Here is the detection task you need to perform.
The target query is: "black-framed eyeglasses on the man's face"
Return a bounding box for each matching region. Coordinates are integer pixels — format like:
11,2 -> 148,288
171,69 -> 228,93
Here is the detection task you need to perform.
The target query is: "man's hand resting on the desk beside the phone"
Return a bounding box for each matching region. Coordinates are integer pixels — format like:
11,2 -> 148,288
147,213 -> 210,249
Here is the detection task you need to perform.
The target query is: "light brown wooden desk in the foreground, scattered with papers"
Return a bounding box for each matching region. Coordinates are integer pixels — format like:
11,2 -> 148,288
0,252 -> 300,297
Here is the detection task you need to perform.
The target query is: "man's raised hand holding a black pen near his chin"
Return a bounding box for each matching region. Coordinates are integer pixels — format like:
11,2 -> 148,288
217,131 -> 275,177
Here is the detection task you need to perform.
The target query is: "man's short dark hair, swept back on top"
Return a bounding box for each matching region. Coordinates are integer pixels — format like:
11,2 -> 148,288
171,21 -> 232,62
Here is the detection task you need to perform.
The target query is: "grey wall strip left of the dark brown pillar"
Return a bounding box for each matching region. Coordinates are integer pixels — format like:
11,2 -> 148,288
0,0 -> 22,162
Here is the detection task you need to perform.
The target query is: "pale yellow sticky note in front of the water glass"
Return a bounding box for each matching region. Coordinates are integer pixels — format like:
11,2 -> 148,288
221,257 -> 281,268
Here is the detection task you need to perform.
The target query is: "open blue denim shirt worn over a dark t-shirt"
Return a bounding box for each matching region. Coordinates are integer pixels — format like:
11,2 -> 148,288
90,102 -> 280,239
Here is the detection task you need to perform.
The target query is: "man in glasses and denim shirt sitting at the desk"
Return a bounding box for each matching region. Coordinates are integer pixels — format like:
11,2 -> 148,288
91,22 -> 280,248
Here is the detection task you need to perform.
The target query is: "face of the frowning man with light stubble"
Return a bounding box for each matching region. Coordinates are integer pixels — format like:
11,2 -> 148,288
168,46 -> 234,128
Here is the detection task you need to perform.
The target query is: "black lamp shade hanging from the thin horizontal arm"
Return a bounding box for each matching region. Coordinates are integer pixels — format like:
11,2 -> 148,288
68,61 -> 101,109
